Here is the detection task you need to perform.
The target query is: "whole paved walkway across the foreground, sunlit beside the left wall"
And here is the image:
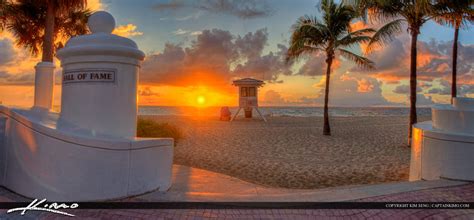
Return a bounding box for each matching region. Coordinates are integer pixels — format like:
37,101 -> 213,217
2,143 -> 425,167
0,165 -> 474,219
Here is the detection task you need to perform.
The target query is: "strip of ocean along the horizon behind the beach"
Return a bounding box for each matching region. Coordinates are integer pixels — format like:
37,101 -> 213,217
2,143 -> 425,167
138,106 -> 431,117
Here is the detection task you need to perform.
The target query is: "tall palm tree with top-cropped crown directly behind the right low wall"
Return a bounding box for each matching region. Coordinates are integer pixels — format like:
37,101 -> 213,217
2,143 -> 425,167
352,0 -> 439,145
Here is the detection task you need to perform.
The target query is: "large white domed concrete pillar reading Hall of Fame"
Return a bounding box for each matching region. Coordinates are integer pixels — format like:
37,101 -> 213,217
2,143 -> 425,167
57,11 -> 145,138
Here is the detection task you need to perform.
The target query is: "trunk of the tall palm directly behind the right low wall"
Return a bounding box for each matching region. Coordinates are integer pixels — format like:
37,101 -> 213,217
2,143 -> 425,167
408,29 -> 419,146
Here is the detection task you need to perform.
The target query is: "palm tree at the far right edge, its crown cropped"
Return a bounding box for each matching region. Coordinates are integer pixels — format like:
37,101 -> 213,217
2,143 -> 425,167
434,0 -> 474,100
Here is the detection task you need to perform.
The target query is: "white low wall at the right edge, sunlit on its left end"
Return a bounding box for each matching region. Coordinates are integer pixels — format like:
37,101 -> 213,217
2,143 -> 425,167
410,122 -> 474,181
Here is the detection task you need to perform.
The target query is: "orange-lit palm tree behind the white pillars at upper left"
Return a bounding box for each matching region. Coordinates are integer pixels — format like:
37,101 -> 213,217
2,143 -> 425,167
5,0 -> 91,62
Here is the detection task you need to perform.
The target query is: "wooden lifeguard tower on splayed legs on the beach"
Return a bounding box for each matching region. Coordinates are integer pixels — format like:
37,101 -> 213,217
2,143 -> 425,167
231,78 -> 267,122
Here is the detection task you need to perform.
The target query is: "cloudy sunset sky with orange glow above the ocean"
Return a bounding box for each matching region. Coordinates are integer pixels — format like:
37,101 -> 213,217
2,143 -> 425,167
0,0 -> 474,107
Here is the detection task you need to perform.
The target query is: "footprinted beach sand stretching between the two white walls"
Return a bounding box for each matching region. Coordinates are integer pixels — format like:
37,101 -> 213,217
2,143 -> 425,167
140,116 -> 428,189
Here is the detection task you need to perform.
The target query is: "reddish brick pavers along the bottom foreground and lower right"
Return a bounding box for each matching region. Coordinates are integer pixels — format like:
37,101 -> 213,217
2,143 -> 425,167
0,183 -> 474,220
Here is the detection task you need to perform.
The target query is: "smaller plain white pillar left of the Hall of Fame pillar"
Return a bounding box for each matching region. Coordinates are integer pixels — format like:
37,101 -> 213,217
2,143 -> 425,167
33,62 -> 55,110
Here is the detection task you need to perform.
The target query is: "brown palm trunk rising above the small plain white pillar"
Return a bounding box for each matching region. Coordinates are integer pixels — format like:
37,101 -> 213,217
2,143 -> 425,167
41,3 -> 55,62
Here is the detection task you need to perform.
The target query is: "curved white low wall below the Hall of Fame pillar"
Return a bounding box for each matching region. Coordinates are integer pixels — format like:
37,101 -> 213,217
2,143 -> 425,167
0,107 -> 173,201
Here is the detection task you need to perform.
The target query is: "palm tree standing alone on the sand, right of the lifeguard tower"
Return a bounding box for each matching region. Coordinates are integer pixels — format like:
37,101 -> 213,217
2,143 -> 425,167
287,0 -> 375,135
